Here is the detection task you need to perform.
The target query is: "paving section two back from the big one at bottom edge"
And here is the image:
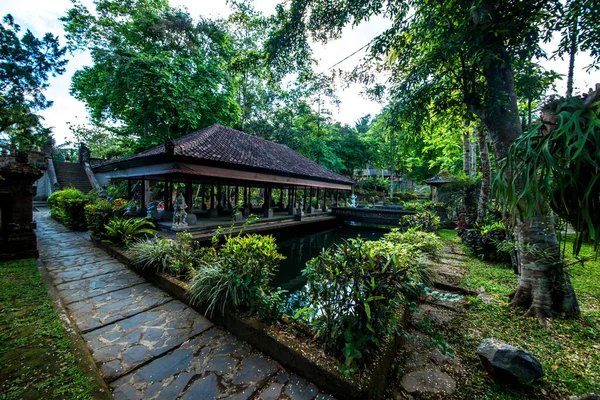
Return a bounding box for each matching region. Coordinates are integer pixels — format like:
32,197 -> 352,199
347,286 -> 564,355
67,283 -> 172,333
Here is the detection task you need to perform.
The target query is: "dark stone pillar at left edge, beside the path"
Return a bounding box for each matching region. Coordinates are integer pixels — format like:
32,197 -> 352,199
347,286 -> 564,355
0,157 -> 43,260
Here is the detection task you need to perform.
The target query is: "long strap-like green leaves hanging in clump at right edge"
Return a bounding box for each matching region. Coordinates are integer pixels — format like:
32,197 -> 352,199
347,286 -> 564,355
495,98 -> 600,254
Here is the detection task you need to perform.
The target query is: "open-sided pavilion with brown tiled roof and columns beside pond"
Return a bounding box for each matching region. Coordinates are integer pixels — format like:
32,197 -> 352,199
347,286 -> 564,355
92,124 -> 354,230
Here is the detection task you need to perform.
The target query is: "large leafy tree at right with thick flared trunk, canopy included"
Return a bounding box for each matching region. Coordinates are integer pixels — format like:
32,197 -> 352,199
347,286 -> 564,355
268,0 -> 579,322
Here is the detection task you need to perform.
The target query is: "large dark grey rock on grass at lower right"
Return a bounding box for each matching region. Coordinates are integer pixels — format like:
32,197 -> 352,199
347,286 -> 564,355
477,339 -> 544,383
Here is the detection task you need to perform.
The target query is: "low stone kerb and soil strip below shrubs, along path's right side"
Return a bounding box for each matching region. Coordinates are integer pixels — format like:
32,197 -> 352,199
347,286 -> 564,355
93,240 -> 408,399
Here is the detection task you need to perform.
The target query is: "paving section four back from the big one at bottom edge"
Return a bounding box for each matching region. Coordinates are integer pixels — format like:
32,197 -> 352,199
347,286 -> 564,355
47,257 -> 125,285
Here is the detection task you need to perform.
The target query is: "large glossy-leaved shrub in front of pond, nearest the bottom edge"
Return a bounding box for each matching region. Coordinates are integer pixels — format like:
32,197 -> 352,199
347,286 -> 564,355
295,239 -> 424,376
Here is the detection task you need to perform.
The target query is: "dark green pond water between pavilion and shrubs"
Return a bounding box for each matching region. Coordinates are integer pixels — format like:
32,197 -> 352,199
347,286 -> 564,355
271,225 -> 389,292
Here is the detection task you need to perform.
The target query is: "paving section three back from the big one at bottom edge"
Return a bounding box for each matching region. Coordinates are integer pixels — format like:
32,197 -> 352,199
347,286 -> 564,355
56,267 -> 146,305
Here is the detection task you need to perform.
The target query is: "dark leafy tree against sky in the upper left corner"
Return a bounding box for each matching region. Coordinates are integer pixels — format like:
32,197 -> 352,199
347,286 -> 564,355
0,14 -> 67,150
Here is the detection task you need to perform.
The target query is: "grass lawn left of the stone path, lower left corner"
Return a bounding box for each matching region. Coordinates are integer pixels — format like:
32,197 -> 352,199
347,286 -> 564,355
0,259 -> 93,399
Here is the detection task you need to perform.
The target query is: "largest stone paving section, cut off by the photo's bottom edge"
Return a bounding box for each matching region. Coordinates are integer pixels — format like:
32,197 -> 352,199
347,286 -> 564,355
111,328 -> 279,400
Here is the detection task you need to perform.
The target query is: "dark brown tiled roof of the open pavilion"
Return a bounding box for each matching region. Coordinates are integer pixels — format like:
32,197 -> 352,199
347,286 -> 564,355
94,124 -> 353,183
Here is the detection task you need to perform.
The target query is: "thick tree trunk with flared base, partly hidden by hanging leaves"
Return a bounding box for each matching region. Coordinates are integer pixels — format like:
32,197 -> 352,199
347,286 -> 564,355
474,4 -> 579,325
